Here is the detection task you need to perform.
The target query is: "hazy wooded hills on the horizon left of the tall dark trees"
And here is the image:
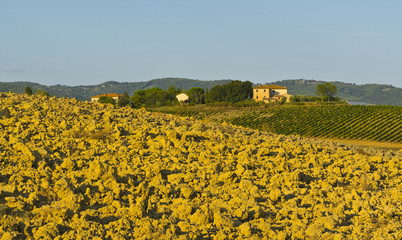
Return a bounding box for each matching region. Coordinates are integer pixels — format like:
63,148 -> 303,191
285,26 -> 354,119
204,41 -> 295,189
0,78 -> 231,100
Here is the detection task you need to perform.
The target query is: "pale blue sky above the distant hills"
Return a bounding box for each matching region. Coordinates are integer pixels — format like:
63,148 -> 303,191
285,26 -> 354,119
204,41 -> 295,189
0,0 -> 402,87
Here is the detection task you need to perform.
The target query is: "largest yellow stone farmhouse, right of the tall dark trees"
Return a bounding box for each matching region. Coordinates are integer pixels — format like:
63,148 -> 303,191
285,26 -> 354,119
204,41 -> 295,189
253,85 -> 292,103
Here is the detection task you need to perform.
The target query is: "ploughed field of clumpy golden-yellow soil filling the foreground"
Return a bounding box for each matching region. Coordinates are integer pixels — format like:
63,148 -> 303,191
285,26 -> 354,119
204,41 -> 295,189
0,93 -> 402,239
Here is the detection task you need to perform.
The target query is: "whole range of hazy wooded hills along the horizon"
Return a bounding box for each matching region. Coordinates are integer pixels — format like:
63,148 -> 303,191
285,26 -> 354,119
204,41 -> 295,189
0,78 -> 402,106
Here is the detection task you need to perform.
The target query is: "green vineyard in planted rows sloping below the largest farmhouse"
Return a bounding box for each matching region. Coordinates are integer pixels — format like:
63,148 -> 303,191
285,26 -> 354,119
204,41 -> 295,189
152,105 -> 402,143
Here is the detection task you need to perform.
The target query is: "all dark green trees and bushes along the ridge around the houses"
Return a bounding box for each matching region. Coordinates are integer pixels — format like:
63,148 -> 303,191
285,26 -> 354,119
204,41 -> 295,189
25,80 -> 339,108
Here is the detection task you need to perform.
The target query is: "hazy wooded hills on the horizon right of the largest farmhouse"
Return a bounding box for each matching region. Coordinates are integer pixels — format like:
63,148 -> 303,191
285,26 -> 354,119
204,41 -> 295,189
267,79 -> 402,106
